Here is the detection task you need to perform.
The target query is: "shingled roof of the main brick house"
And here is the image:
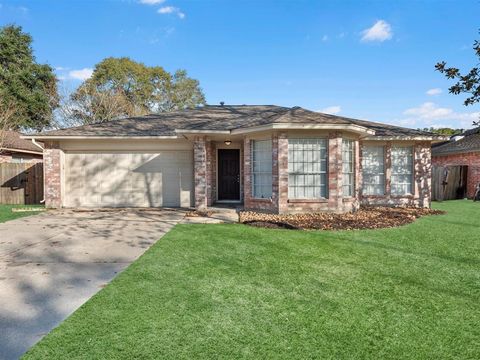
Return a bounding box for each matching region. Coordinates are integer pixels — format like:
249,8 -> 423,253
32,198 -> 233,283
24,105 -> 443,139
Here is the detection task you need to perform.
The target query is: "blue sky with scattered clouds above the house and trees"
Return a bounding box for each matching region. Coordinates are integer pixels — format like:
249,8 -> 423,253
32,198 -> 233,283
0,0 -> 480,128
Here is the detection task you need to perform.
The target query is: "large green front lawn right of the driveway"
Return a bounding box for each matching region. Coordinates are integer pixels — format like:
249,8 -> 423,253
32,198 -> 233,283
25,201 -> 480,359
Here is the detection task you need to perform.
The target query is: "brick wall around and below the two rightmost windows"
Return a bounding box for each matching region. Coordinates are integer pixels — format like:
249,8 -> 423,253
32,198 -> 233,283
360,142 -> 432,207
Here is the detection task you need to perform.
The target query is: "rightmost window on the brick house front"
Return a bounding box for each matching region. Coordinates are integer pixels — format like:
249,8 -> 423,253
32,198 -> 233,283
392,146 -> 413,196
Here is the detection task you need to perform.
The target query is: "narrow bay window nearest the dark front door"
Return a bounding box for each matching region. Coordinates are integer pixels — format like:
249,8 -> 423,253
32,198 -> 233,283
251,140 -> 272,198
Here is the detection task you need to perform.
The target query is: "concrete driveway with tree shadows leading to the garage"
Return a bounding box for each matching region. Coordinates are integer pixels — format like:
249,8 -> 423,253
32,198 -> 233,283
0,210 -> 184,359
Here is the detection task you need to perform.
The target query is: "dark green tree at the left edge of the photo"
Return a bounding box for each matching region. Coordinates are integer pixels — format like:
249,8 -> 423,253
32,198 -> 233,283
0,25 -> 58,130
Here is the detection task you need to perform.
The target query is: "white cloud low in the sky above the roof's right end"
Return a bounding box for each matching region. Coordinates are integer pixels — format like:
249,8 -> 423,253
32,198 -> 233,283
399,102 -> 480,128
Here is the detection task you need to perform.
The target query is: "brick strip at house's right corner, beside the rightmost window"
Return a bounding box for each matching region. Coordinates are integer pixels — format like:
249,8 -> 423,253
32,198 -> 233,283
414,142 -> 432,207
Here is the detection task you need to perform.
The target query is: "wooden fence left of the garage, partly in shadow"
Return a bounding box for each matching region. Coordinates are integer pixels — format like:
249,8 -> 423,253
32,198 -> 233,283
0,163 -> 43,205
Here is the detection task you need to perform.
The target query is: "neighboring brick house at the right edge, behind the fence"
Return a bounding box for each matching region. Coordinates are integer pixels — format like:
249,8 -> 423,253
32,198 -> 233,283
432,127 -> 480,198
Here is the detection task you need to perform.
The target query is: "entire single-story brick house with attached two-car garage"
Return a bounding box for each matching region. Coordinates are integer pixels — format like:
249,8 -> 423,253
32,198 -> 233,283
21,105 -> 444,213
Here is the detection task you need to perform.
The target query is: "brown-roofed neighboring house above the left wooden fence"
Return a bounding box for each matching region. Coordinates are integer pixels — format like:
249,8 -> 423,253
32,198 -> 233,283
0,130 -> 43,163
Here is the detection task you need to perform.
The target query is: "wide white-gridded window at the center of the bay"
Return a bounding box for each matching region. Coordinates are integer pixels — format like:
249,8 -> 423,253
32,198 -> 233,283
288,139 -> 328,199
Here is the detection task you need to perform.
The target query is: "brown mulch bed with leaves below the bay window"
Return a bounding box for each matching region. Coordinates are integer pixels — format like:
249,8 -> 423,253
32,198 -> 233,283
240,207 -> 445,230
